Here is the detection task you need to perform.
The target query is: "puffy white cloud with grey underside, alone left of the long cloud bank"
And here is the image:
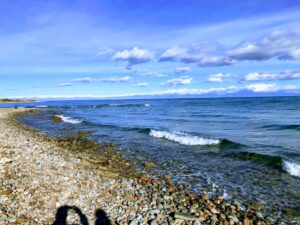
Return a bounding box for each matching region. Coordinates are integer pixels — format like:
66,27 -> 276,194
112,47 -> 154,68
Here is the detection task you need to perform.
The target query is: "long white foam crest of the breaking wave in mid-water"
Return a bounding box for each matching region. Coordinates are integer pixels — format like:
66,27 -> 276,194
149,129 -> 221,145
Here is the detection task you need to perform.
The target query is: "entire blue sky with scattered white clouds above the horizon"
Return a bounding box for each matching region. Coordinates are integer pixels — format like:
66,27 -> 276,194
0,0 -> 300,99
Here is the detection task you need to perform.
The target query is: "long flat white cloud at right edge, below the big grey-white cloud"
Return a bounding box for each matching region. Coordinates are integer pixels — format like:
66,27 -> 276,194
244,71 -> 300,81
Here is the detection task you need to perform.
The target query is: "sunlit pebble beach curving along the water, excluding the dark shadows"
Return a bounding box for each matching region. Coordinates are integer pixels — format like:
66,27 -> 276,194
0,109 -> 286,225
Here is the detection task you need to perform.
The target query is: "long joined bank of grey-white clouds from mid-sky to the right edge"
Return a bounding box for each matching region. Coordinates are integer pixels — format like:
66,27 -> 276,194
159,31 -> 300,67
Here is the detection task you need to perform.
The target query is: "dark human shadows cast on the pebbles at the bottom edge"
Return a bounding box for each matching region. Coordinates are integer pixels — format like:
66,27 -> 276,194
52,205 -> 110,225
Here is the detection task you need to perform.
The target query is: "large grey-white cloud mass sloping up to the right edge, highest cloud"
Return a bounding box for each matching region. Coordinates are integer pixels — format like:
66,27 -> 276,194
228,31 -> 300,60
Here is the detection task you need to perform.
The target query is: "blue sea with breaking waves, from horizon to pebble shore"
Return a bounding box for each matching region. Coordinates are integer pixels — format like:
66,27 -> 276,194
1,97 -> 300,220
